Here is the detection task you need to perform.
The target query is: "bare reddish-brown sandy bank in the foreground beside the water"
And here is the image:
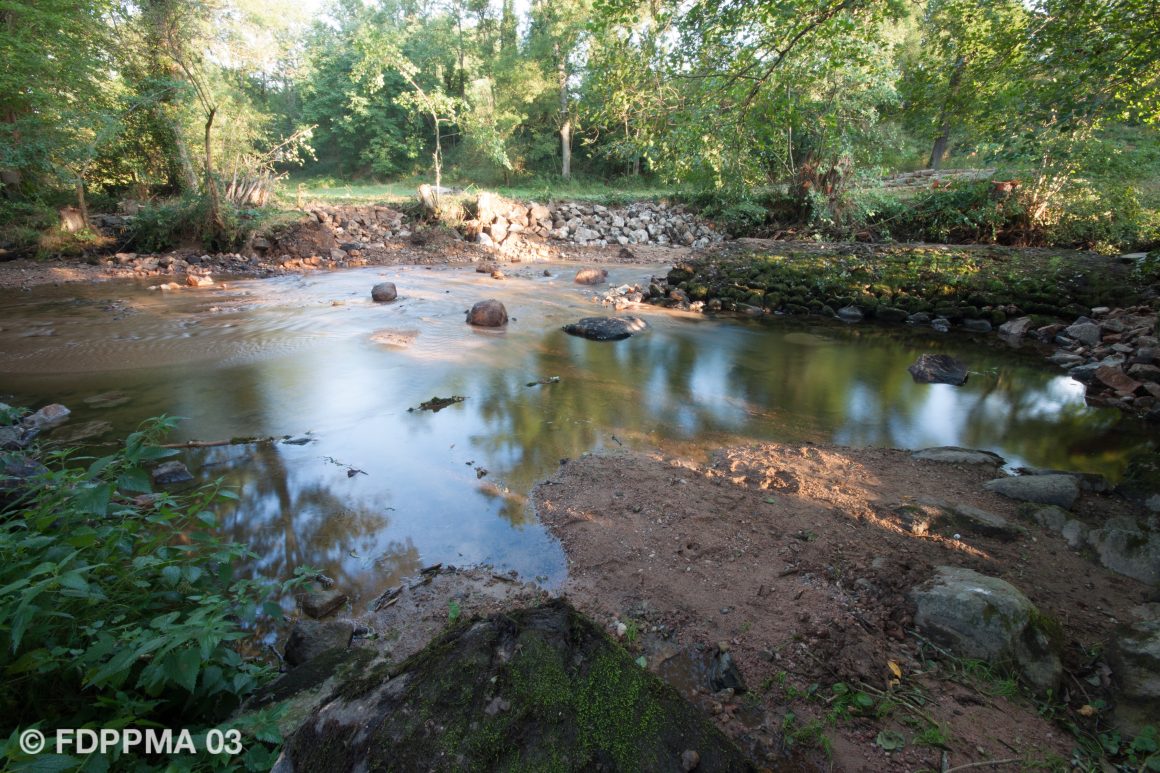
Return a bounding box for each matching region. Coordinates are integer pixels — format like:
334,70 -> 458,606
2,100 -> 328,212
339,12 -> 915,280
535,445 -> 1148,772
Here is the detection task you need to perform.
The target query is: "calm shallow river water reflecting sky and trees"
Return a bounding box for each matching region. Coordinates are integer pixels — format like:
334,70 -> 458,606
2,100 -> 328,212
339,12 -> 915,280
0,265 -> 1150,600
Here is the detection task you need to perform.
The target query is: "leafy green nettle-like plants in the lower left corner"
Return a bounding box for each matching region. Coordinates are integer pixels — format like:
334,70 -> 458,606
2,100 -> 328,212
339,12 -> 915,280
0,417 -> 310,768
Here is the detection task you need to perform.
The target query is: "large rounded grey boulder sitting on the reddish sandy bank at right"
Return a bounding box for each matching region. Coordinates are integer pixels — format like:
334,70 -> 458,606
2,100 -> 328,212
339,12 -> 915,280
911,559 -> 1063,694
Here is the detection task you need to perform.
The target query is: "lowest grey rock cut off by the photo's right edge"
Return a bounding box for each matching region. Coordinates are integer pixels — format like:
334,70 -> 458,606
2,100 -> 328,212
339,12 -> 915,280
1108,604 -> 1160,735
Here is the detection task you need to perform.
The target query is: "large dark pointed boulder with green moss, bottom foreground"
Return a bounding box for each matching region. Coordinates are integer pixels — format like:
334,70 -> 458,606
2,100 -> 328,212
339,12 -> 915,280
274,600 -> 754,773
